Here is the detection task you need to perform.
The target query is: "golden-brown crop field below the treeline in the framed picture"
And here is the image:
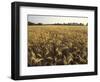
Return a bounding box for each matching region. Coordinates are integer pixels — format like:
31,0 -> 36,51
28,25 -> 88,66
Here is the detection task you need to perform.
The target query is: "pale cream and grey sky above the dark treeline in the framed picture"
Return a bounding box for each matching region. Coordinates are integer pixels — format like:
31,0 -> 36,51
27,15 -> 88,24
